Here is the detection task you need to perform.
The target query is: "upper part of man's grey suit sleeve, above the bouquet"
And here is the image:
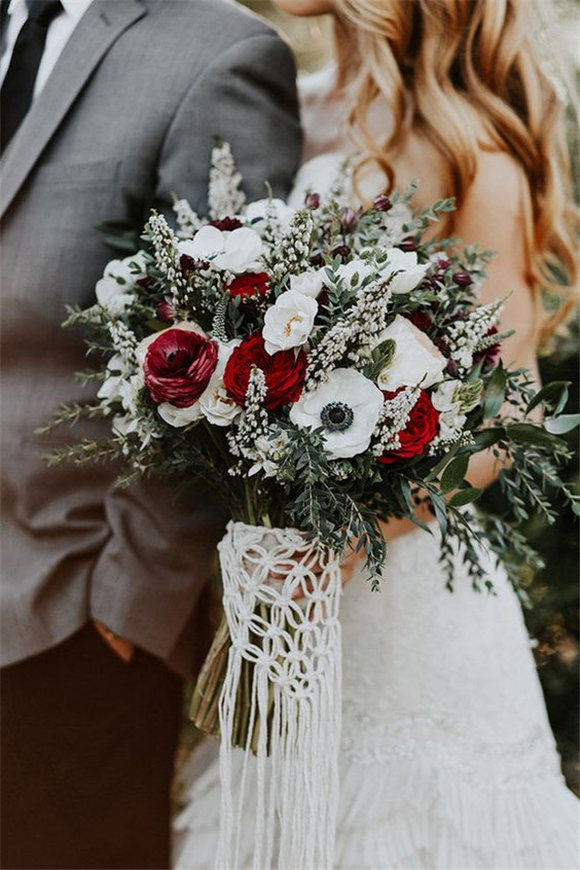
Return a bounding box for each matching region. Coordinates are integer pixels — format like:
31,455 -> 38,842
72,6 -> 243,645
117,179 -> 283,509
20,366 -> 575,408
157,31 -> 302,214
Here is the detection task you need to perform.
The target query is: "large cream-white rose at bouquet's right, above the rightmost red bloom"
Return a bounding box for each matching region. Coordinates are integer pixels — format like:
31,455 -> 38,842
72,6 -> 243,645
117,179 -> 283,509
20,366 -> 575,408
375,314 -> 447,392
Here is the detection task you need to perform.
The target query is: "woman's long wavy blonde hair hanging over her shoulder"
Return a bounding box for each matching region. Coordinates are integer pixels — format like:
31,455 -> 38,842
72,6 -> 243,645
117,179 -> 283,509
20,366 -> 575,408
335,0 -> 577,339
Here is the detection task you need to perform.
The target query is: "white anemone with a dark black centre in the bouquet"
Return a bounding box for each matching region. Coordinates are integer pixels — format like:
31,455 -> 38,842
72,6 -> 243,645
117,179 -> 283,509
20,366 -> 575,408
290,369 -> 384,459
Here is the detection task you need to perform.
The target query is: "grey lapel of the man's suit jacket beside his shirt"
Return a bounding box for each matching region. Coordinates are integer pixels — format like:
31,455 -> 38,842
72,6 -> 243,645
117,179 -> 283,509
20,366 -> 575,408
0,0 -> 146,215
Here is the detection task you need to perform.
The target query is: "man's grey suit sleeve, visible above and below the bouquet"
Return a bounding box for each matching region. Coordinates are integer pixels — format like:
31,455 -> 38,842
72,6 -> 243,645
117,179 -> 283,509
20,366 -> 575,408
90,30 -> 301,673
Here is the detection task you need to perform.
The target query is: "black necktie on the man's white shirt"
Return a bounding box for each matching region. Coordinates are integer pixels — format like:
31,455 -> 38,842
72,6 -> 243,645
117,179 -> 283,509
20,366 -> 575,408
0,0 -> 62,152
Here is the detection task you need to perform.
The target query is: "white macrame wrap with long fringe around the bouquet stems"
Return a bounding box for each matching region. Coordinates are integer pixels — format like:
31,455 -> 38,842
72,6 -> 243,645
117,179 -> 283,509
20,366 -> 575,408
216,522 -> 342,870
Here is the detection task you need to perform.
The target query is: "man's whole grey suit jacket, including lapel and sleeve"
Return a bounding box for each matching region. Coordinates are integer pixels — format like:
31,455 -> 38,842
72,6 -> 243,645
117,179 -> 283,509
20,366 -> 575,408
0,0 -> 301,673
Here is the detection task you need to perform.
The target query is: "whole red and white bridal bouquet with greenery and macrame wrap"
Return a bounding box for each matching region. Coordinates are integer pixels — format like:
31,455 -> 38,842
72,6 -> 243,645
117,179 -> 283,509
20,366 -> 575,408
43,144 -> 574,867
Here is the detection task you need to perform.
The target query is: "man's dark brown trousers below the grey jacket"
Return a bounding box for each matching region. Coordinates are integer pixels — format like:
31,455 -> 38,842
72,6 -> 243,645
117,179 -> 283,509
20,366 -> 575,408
0,625 -> 182,870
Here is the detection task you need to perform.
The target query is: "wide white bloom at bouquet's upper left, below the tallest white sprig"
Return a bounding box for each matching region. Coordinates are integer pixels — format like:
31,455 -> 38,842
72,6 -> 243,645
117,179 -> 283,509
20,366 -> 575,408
184,226 -> 262,274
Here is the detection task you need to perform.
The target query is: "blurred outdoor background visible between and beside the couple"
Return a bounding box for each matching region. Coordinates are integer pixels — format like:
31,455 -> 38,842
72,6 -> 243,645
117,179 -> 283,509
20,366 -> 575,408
190,0 -> 580,793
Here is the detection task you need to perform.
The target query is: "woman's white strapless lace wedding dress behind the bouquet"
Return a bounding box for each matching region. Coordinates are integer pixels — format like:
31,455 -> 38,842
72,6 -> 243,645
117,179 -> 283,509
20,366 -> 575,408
174,70 -> 580,870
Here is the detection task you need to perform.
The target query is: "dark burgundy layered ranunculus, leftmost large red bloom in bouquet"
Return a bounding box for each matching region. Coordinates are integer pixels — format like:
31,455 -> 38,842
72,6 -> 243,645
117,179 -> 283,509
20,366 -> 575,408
143,328 -> 218,408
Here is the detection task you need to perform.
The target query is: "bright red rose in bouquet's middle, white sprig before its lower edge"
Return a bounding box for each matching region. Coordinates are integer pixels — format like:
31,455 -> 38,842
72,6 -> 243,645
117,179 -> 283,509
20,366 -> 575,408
224,333 -> 306,410
